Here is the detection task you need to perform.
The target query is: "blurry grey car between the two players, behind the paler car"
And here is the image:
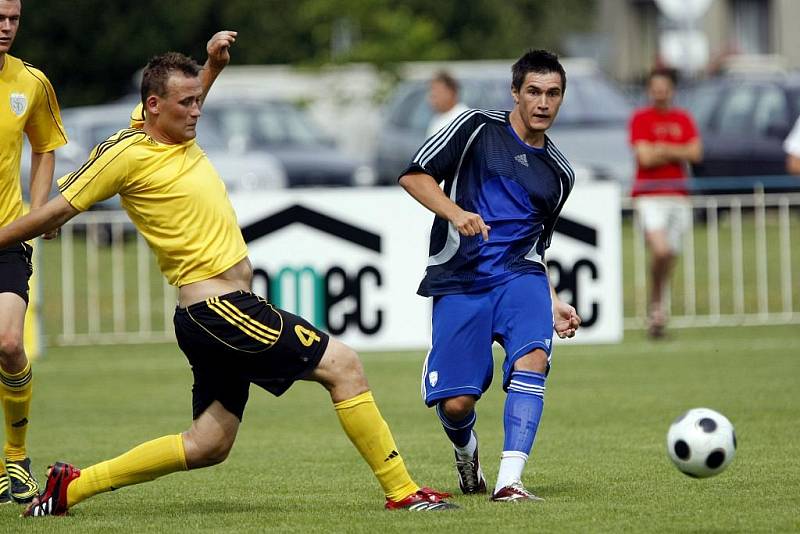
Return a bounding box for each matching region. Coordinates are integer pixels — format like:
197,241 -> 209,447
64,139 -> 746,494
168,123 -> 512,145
197,93 -> 375,187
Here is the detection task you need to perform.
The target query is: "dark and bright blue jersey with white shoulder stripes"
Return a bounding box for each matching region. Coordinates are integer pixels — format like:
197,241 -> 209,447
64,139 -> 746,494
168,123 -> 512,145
403,109 -> 575,296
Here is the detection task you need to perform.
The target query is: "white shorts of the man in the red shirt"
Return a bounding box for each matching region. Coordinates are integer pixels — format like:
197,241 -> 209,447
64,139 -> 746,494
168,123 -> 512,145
634,195 -> 692,253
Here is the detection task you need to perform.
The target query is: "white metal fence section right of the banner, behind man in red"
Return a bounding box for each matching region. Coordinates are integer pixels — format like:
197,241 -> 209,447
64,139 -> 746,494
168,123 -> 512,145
624,191 -> 800,328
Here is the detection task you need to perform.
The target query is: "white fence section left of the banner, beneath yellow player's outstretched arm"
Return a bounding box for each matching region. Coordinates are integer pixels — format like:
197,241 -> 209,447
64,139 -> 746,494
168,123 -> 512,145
50,211 -> 176,345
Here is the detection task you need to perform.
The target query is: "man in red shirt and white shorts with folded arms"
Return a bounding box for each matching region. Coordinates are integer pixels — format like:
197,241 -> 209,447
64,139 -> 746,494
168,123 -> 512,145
630,69 -> 703,338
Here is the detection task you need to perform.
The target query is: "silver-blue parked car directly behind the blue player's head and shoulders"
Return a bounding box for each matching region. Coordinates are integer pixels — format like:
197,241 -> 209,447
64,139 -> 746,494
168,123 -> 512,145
375,59 -> 634,187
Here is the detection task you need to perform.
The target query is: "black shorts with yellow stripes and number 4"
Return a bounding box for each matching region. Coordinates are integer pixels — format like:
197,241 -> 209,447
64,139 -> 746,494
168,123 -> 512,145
174,291 -> 330,420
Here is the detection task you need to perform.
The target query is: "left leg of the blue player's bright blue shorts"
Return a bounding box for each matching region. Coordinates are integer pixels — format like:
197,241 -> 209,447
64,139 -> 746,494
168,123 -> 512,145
422,291 -> 493,406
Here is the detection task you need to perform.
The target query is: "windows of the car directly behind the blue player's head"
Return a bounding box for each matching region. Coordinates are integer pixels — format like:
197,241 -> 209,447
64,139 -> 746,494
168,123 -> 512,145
390,76 -> 631,130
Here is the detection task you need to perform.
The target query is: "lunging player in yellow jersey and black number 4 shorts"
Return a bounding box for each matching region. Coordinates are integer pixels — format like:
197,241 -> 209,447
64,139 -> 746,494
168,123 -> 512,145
0,43 -> 455,517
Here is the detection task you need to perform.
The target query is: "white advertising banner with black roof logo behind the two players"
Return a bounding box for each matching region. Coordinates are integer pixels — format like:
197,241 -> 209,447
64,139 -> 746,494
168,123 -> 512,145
231,186 -> 622,350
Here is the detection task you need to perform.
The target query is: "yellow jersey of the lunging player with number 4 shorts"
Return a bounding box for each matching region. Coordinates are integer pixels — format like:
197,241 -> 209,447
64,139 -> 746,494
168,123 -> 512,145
58,128 -> 247,287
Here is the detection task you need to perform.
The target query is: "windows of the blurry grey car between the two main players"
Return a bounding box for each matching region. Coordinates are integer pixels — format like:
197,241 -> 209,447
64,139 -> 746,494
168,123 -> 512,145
197,102 -> 324,149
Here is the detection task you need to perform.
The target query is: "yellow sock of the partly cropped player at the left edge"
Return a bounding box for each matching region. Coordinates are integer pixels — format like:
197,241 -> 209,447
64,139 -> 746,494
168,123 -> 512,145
0,363 -> 33,461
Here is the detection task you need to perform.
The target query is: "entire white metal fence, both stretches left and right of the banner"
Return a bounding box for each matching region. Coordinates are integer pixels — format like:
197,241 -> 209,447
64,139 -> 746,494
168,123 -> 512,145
37,189 -> 800,345
